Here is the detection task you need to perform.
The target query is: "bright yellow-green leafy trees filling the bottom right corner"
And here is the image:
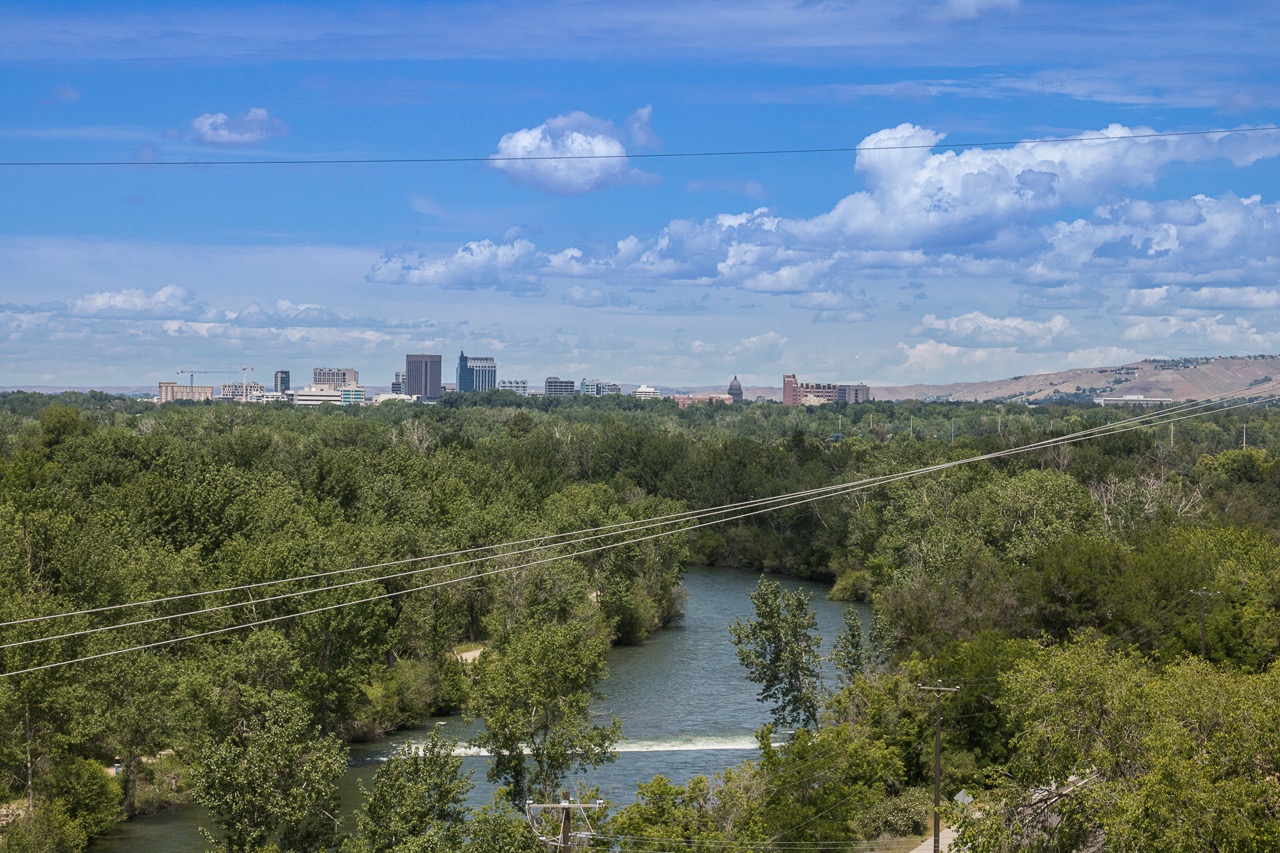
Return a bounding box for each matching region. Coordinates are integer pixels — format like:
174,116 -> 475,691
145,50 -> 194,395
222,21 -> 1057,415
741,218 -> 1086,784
963,639 -> 1280,852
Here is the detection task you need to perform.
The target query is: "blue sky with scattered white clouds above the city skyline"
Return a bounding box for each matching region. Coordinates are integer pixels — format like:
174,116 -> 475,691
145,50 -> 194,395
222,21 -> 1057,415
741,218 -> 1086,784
0,0 -> 1280,386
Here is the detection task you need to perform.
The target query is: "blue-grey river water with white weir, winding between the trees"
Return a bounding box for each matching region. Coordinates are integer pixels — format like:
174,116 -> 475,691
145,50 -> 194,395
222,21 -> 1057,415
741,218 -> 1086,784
91,567 -> 869,853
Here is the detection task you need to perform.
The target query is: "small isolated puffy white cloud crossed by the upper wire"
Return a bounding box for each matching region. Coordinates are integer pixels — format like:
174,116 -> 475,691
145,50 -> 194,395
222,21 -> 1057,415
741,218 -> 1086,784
489,108 -> 657,196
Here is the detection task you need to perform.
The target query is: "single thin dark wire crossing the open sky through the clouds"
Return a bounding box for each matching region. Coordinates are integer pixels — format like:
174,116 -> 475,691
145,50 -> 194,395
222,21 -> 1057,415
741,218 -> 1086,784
0,126 -> 1280,168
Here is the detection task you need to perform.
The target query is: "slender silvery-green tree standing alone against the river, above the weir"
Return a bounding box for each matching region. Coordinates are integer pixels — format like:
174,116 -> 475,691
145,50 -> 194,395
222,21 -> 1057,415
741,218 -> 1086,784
728,578 -> 822,726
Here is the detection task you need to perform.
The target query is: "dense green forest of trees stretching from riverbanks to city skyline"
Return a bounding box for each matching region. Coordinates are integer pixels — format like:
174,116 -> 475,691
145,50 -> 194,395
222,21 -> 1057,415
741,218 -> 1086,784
0,392 -> 1280,853
